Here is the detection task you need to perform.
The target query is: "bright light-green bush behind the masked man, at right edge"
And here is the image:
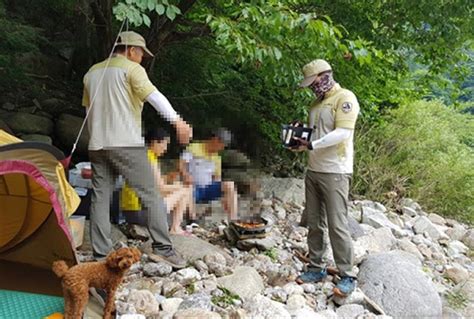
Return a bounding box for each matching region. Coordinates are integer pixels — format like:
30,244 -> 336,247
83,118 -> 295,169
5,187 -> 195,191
354,101 -> 474,223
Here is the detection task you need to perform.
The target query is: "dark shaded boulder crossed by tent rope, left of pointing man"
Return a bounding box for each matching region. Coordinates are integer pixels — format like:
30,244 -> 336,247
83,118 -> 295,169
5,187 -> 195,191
55,114 -> 89,154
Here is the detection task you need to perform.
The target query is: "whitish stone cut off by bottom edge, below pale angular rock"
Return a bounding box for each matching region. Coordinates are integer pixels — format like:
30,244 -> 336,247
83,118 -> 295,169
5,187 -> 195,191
244,294 -> 291,319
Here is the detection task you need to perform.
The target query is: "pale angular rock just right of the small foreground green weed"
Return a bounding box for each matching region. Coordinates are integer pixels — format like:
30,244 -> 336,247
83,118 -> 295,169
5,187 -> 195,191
217,266 -> 264,300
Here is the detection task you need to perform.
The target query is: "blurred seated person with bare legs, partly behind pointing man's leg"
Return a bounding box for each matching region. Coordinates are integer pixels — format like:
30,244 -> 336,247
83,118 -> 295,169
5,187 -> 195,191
121,128 -> 195,234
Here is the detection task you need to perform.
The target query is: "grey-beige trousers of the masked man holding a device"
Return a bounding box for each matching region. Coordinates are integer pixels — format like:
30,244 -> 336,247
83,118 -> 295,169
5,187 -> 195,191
302,170 -> 356,277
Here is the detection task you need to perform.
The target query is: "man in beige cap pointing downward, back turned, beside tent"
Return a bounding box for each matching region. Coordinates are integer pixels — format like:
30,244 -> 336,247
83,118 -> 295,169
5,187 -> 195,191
83,31 -> 192,268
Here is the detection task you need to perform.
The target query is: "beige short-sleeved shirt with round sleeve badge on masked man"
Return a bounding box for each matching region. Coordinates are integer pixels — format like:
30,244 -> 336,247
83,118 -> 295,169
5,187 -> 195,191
308,83 -> 359,174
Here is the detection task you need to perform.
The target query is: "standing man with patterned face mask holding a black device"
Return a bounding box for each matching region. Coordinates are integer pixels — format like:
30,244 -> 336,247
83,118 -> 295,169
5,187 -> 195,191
297,59 -> 359,296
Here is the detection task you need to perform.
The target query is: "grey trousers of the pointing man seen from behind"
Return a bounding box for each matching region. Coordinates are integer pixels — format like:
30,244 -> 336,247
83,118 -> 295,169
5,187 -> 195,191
89,147 -> 172,255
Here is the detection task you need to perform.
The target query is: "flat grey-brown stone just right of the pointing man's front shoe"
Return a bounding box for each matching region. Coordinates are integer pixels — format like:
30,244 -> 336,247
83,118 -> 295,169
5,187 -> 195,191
171,235 -> 232,261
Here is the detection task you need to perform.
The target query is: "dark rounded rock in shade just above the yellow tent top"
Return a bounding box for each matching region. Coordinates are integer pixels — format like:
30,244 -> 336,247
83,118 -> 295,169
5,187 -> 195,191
6,113 -> 53,136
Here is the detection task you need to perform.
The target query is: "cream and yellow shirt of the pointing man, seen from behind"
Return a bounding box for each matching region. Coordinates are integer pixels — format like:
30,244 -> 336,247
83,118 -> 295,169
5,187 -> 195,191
82,55 -> 156,151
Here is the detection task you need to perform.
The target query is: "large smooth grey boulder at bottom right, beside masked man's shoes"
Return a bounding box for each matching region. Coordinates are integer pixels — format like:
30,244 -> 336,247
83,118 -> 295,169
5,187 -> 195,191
358,250 -> 442,318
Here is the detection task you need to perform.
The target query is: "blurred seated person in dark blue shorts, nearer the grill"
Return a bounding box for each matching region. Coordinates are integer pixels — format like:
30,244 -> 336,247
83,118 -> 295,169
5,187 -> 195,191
179,128 -> 237,220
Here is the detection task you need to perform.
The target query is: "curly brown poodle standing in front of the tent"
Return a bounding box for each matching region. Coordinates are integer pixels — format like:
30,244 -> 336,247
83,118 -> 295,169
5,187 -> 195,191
53,247 -> 141,319
